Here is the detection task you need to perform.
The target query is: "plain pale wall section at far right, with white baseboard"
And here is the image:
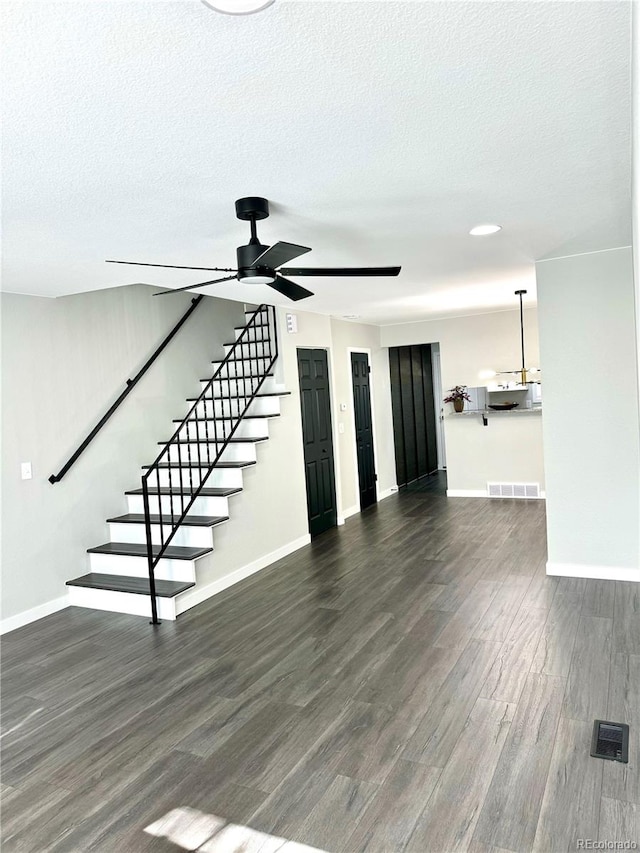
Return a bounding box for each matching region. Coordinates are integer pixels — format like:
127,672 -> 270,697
536,248 -> 640,580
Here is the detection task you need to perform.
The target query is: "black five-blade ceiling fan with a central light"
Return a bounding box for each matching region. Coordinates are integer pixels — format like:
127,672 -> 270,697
106,196 -> 400,301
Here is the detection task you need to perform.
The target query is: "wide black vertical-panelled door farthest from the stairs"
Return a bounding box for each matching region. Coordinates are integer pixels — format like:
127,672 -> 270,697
389,344 -> 438,486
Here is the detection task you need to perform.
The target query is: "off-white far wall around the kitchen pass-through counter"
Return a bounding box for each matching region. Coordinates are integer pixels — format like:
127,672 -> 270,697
380,306 -> 545,495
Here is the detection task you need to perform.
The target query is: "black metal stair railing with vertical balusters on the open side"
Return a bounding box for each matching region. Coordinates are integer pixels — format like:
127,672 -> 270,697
142,305 -> 278,625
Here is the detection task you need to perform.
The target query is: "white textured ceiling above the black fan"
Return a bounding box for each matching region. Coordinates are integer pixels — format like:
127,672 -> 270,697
2,0 -> 630,324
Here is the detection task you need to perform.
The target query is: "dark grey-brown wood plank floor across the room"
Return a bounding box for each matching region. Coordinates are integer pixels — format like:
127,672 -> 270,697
2,484 -> 640,853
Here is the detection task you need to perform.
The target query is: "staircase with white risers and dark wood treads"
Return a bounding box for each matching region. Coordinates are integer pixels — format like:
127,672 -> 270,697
67,305 -> 289,622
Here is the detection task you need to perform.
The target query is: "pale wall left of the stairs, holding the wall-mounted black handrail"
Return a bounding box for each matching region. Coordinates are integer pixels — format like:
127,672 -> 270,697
0,285 -> 243,619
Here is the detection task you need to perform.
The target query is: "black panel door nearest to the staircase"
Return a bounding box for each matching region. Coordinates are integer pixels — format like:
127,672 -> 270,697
298,349 -> 338,536
